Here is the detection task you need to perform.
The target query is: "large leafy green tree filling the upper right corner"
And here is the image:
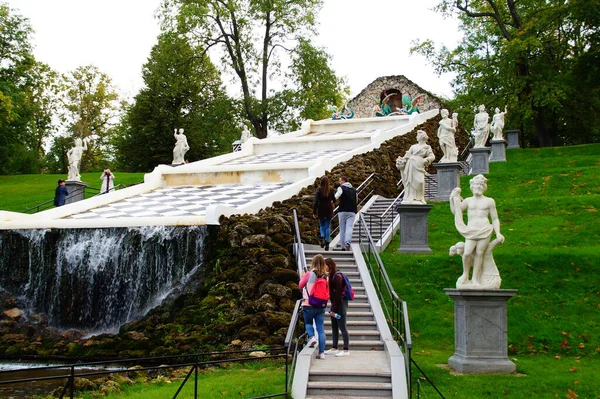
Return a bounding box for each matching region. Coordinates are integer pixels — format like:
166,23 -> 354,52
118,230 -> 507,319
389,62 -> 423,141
413,0 -> 600,146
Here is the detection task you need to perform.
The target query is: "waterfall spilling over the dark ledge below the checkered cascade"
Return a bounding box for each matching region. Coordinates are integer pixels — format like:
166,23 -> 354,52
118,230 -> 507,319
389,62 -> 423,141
0,226 -> 207,332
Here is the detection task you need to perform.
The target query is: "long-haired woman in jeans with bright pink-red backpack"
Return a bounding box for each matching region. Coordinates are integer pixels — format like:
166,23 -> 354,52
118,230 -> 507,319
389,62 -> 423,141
298,254 -> 329,359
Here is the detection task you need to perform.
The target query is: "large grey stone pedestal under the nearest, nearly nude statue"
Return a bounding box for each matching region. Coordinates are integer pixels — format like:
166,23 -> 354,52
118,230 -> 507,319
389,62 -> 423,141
444,288 -> 517,374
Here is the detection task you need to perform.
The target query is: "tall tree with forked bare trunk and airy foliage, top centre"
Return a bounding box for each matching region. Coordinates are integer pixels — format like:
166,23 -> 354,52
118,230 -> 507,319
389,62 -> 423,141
163,0 -> 344,138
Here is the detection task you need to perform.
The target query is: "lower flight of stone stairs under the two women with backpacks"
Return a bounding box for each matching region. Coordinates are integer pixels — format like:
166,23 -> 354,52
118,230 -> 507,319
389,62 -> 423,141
305,247 -> 392,399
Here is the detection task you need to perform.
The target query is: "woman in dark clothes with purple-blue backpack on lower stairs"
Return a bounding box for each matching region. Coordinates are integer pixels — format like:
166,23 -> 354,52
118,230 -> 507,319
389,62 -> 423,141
325,258 -> 350,357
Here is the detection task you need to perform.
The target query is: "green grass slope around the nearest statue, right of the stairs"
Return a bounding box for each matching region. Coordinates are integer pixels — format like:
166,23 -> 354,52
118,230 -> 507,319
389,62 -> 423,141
382,145 -> 600,399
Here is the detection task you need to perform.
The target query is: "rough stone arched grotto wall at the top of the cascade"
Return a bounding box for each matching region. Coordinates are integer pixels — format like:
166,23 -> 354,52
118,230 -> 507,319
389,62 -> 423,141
348,75 -> 447,118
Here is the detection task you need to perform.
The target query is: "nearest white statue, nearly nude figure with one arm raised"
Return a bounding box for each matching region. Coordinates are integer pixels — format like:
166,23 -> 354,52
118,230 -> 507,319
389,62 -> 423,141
450,175 -> 504,289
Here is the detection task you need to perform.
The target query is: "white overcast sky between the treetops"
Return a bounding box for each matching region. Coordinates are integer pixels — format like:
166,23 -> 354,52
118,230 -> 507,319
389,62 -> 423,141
0,0 -> 460,98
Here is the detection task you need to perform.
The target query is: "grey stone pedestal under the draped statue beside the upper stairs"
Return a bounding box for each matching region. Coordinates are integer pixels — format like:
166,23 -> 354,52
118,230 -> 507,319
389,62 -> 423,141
398,204 -> 433,254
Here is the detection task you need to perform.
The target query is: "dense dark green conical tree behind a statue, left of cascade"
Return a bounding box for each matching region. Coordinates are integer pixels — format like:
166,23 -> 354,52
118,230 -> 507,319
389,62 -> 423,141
114,32 -> 239,171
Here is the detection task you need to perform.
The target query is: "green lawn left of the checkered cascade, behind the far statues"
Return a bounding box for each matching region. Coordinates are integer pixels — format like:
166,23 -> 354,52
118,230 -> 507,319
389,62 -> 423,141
0,172 -> 144,212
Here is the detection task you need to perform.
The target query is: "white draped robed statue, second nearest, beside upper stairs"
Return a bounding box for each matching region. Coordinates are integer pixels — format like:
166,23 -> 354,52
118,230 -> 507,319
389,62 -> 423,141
396,130 -> 435,204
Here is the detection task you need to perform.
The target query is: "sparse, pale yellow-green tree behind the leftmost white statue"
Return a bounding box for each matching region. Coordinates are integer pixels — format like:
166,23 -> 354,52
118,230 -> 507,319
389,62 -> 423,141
61,65 -> 122,171
